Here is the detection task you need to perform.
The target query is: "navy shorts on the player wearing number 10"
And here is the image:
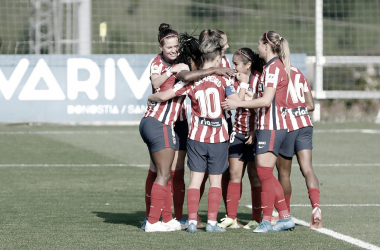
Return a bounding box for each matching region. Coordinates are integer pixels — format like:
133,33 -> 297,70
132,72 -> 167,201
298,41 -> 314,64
187,139 -> 228,175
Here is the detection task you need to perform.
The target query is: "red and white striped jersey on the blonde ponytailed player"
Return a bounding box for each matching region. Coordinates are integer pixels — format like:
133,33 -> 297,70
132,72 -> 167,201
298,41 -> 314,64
256,56 -> 289,130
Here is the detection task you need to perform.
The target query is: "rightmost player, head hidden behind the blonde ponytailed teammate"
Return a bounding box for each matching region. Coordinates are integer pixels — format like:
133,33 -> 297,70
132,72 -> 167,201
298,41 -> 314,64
276,67 -> 322,228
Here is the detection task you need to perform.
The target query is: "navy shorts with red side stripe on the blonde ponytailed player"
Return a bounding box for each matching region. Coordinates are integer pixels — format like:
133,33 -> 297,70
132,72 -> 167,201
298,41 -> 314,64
255,129 -> 288,156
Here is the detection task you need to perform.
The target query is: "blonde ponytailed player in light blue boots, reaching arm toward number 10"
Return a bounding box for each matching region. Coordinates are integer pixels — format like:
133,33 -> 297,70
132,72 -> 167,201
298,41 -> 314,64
222,31 -> 295,233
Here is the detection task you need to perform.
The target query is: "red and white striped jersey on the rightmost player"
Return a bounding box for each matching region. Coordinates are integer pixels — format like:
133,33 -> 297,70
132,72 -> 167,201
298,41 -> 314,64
286,66 -> 313,132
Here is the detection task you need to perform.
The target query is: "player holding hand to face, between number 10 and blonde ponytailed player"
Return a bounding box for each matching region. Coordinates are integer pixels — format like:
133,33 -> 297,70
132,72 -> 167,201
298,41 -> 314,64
219,48 -> 264,229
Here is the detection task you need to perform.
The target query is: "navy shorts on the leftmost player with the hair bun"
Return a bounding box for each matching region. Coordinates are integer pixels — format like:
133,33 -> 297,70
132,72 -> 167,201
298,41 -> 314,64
139,117 -> 177,153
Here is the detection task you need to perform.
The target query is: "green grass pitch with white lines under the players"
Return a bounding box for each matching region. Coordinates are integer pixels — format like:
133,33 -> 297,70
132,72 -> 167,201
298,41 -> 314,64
0,123 -> 380,249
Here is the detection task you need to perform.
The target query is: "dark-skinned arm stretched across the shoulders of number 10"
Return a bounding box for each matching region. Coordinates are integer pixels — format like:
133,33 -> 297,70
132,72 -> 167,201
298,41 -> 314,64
177,68 -> 234,82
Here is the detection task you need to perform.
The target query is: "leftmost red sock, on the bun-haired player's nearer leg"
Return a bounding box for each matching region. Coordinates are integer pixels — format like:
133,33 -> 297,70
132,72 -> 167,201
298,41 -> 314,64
148,183 -> 170,224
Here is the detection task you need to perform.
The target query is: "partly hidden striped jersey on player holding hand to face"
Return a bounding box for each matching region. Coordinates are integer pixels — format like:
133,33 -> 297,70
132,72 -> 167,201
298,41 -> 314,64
232,70 -> 261,135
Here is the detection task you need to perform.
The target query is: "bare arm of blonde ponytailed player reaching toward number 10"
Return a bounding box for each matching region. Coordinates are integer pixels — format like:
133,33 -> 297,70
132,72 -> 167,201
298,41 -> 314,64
222,87 -> 276,110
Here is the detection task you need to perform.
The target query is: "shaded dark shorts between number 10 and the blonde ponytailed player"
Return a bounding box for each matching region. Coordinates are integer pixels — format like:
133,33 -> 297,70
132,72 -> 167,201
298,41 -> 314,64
228,132 -> 255,161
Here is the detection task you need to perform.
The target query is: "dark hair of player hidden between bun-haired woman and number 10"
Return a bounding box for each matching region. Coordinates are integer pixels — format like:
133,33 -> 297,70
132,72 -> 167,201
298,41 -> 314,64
174,32 -> 202,70
